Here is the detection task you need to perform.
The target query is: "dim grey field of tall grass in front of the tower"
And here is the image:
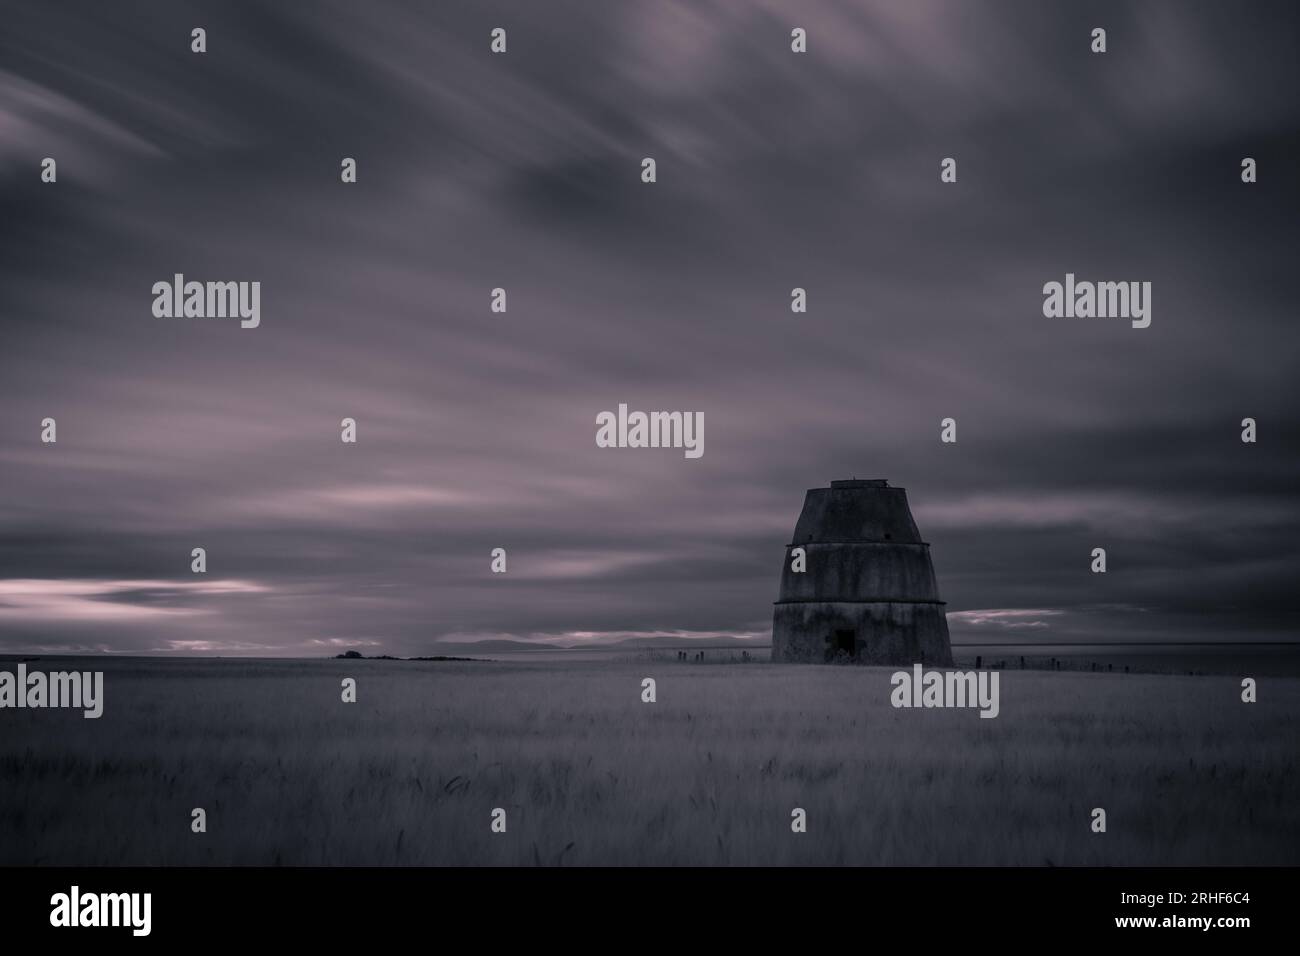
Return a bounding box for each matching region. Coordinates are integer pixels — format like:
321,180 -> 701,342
0,658 -> 1300,865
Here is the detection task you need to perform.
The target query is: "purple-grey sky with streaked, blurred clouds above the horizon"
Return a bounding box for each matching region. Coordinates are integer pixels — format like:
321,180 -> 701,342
0,0 -> 1300,654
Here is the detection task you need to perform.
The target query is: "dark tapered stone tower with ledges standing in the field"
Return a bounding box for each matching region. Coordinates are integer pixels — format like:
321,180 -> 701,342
772,480 -> 953,666
